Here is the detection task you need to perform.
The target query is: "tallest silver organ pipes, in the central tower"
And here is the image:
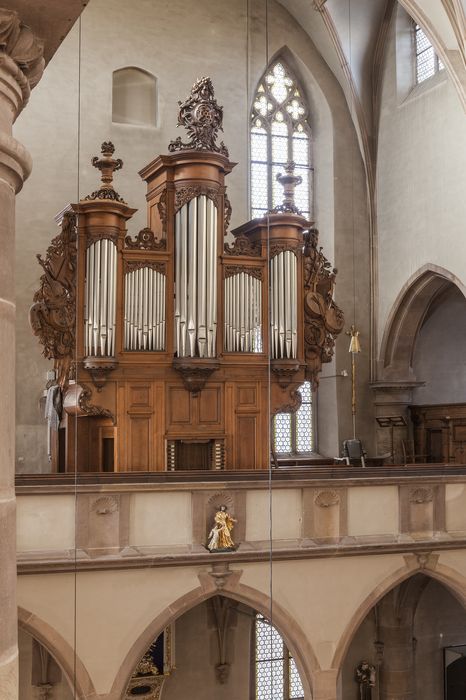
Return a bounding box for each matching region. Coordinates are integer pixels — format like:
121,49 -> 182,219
175,194 -> 217,357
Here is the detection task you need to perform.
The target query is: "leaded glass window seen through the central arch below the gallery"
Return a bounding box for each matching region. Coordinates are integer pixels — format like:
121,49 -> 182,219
255,614 -> 304,700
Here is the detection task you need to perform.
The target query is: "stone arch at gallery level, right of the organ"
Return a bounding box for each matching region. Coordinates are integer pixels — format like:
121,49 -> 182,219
380,264 -> 466,381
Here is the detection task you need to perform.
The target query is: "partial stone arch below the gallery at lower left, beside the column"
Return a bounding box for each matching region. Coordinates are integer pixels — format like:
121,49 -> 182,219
18,607 -> 97,700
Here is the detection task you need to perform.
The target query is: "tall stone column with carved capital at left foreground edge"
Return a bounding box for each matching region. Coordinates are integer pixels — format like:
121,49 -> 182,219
0,8 -> 44,700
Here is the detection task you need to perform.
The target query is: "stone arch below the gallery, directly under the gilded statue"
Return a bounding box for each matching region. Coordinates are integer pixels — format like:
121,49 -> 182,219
107,572 -> 320,700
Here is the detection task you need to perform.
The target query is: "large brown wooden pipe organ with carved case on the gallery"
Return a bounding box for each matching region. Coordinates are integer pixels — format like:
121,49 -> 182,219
31,78 -> 343,471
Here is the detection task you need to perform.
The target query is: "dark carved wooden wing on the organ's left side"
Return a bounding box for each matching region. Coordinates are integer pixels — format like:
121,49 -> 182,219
29,212 -> 77,388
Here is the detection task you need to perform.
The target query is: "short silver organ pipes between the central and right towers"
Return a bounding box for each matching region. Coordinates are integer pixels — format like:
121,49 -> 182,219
224,271 -> 262,352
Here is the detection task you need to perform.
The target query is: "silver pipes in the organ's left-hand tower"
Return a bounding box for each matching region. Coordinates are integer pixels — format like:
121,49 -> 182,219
84,238 -> 117,357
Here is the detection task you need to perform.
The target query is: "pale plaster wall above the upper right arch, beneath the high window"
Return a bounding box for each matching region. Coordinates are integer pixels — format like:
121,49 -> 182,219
377,8 -> 466,360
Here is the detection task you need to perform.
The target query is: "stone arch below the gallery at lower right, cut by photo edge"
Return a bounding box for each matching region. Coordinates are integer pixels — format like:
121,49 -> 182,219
332,553 -> 466,673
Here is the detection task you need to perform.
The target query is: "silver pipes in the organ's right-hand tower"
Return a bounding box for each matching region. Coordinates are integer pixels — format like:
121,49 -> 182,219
270,250 -> 298,360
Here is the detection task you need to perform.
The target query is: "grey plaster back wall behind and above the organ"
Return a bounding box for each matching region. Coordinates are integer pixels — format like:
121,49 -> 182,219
16,0 -> 372,472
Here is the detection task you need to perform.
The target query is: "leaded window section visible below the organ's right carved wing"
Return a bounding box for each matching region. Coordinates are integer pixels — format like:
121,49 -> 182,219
273,382 -> 314,454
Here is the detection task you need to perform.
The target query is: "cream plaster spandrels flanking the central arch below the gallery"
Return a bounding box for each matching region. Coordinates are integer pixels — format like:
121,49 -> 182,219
18,554 -> 404,694
